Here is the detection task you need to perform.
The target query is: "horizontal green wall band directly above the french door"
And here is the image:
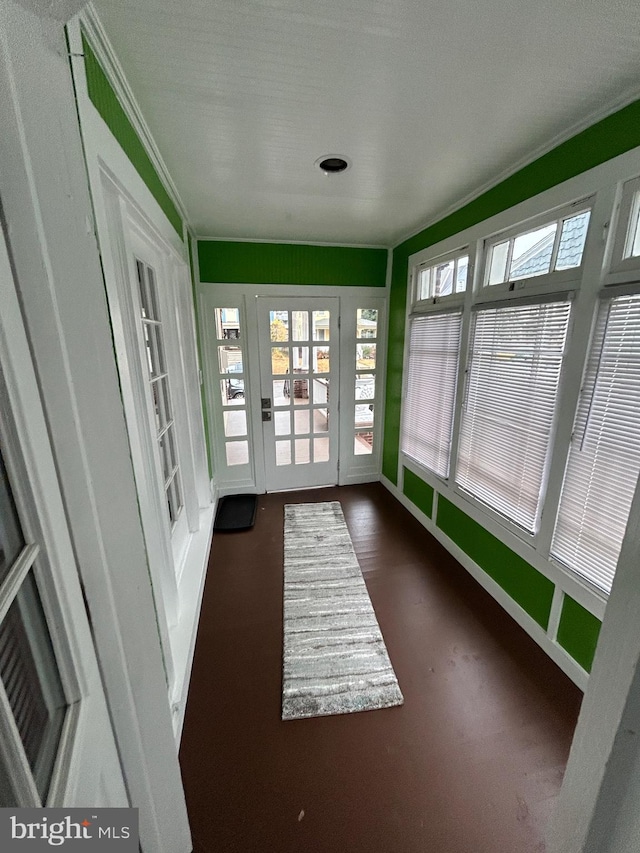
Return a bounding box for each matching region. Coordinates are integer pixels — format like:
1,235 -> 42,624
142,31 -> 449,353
198,240 -> 387,287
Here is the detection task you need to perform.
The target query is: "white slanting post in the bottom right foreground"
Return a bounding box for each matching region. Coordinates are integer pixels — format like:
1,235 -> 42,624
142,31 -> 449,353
549,466 -> 640,853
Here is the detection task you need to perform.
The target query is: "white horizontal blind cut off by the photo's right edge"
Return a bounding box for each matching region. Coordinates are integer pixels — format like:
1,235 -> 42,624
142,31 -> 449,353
551,294 -> 640,592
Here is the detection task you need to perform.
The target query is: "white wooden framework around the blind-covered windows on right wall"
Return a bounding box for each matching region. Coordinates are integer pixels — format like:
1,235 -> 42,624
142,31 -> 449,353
397,149 -> 640,652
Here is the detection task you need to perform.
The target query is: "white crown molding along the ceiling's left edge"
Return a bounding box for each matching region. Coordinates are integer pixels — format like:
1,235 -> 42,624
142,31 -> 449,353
78,3 -> 192,238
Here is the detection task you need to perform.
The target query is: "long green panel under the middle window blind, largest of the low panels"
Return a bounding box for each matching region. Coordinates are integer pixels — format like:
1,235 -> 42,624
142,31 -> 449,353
436,495 -> 554,630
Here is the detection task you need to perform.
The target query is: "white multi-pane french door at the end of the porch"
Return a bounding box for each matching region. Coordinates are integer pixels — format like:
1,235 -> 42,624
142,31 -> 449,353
257,297 -> 340,491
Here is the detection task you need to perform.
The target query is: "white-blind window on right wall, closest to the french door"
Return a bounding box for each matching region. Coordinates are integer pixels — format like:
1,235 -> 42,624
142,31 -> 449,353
402,313 -> 462,477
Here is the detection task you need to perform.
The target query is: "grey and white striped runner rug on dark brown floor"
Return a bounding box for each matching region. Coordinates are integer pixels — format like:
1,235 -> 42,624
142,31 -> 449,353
282,501 -> 404,720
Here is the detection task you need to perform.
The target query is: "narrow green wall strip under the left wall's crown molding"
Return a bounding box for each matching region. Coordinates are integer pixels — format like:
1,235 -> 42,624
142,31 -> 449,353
82,33 -> 183,239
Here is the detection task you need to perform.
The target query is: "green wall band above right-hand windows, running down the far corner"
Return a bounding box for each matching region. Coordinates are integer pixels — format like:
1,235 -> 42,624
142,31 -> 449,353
383,100 -> 640,483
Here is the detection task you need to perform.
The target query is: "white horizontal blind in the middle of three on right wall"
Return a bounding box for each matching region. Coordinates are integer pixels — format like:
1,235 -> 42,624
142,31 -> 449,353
456,301 -> 570,533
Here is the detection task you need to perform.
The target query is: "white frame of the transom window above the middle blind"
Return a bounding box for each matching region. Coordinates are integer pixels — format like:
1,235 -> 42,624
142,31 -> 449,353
474,195 -> 595,302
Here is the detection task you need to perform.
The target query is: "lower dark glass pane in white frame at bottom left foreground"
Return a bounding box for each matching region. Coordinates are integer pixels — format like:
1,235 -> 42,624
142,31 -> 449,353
0,571 -> 66,799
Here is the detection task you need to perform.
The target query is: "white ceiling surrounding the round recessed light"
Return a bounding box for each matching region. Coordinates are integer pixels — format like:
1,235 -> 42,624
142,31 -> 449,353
94,0 -> 640,245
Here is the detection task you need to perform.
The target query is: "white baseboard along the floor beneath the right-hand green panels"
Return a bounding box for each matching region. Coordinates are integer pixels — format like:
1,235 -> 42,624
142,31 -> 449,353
380,475 -> 589,691
